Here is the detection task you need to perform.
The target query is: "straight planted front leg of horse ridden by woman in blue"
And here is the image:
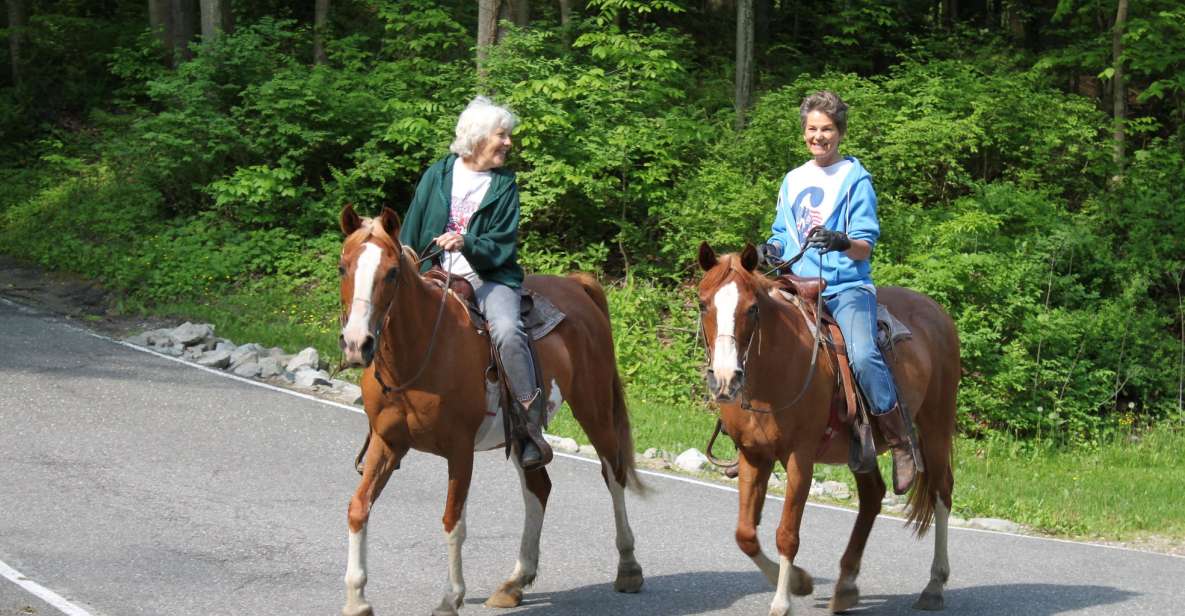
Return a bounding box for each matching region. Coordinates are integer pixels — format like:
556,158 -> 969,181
769,451 -> 814,616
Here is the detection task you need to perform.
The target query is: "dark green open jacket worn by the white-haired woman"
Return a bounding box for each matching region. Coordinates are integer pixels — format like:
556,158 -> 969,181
399,154 -> 523,288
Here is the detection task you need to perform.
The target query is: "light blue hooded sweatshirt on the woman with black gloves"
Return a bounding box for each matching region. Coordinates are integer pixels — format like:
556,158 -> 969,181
769,156 -> 880,297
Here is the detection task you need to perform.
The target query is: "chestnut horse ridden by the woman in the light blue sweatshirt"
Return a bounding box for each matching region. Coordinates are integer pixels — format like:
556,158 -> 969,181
699,243 -> 960,616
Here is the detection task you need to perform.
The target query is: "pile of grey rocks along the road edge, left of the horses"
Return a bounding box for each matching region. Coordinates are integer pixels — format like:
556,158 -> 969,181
127,322 -> 361,404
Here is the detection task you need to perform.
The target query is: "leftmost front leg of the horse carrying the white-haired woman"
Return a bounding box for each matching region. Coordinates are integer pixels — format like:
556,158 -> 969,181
341,434 -> 408,616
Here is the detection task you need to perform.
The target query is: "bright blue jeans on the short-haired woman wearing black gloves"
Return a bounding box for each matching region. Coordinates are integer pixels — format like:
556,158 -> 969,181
824,287 -> 897,415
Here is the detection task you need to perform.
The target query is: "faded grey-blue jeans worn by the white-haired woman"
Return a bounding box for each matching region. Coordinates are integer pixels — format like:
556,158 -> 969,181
474,281 -> 538,403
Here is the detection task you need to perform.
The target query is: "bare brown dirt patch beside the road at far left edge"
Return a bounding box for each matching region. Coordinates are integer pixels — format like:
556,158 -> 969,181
0,255 -> 177,338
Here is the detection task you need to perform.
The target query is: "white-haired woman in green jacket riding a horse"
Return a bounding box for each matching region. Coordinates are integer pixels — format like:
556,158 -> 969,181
399,96 -> 551,470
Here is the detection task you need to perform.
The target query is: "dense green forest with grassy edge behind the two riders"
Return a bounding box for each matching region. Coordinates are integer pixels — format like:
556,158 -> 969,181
0,0 -> 1185,537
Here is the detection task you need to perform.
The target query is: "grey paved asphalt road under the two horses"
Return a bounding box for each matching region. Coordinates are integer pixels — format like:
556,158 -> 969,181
0,296 -> 1185,616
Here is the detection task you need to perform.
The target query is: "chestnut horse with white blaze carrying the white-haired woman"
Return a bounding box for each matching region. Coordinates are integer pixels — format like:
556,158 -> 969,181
339,206 -> 642,616
